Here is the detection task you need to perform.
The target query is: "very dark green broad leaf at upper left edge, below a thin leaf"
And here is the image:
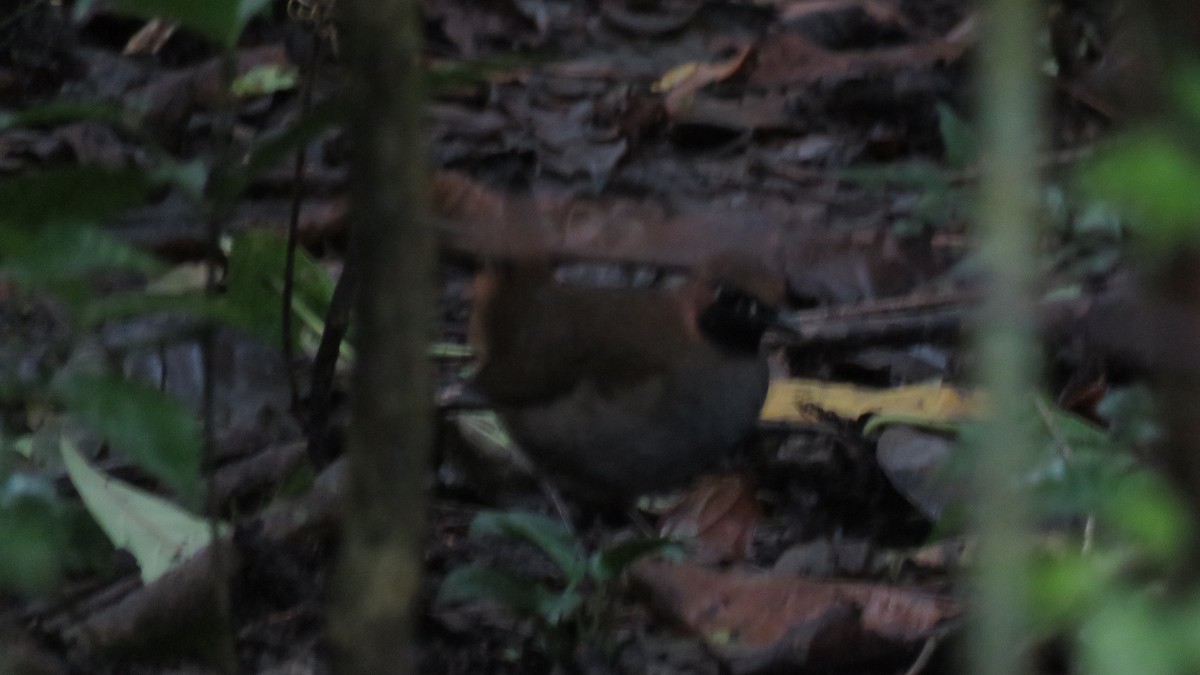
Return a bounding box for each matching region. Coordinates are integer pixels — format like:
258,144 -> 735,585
0,166 -> 158,229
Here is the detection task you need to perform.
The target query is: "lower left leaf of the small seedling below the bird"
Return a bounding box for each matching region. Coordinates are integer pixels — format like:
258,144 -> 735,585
436,565 -> 581,625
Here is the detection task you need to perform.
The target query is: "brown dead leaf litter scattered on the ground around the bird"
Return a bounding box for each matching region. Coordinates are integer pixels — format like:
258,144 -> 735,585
0,0 -> 1132,673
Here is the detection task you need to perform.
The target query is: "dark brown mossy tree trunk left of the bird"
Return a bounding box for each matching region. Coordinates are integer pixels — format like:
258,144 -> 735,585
329,0 -> 434,675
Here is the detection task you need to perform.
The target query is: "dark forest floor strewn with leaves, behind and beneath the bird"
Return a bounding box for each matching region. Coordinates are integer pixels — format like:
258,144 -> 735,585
0,0 -> 1120,674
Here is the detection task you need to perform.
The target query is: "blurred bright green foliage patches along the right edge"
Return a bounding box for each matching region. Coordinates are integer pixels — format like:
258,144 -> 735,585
1033,62 -> 1200,675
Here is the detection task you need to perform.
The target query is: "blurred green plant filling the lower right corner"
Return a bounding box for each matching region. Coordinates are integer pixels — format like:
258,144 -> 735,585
1003,388 -> 1200,675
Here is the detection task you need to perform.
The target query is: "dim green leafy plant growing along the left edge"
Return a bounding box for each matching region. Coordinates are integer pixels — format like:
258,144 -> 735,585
0,0 -> 336,592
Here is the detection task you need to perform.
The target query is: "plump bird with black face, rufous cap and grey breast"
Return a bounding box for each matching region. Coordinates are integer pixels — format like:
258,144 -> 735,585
468,253 -> 784,506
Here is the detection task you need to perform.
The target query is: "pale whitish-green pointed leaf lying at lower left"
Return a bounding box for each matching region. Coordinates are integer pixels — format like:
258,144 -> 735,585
59,440 -> 228,584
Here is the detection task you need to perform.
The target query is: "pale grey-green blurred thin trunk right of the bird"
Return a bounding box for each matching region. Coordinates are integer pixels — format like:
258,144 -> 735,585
970,0 -> 1040,675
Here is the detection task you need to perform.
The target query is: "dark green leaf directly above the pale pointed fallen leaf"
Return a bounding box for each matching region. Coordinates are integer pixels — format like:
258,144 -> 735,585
53,375 -> 200,503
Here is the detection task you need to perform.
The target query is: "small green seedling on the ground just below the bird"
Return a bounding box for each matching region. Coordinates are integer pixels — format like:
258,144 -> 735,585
437,510 -> 679,661
